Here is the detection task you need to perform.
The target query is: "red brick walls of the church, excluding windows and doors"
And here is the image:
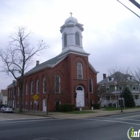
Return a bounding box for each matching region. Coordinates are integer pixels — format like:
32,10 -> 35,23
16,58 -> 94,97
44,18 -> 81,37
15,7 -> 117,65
8,54 -> 97,110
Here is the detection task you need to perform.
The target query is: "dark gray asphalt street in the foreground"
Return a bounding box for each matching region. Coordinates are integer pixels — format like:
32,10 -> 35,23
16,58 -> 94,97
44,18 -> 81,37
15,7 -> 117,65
0,112 -> 140,140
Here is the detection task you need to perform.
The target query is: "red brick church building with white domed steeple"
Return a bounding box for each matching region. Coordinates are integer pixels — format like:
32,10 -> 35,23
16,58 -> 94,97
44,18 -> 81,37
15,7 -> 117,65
8,16 -> 97,111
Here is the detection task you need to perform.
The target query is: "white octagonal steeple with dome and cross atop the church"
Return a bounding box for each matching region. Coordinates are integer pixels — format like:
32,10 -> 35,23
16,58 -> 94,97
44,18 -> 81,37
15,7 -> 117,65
60,13 -> 86,53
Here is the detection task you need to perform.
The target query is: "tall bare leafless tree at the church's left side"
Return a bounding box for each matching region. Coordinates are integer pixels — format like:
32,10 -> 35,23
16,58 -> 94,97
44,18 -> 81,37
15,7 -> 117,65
0,27 -> 47,112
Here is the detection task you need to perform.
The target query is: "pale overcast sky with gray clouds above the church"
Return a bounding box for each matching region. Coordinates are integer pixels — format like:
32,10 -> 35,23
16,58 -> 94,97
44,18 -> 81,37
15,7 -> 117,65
0,0 -> 140,89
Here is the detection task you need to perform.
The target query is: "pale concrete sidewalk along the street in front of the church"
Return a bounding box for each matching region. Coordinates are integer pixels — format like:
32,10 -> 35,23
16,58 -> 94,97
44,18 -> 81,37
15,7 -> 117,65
14,108 -> 140,119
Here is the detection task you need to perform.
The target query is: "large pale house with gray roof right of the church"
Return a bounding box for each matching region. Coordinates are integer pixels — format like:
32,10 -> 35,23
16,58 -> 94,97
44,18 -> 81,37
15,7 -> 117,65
98,72 -> 140,107
